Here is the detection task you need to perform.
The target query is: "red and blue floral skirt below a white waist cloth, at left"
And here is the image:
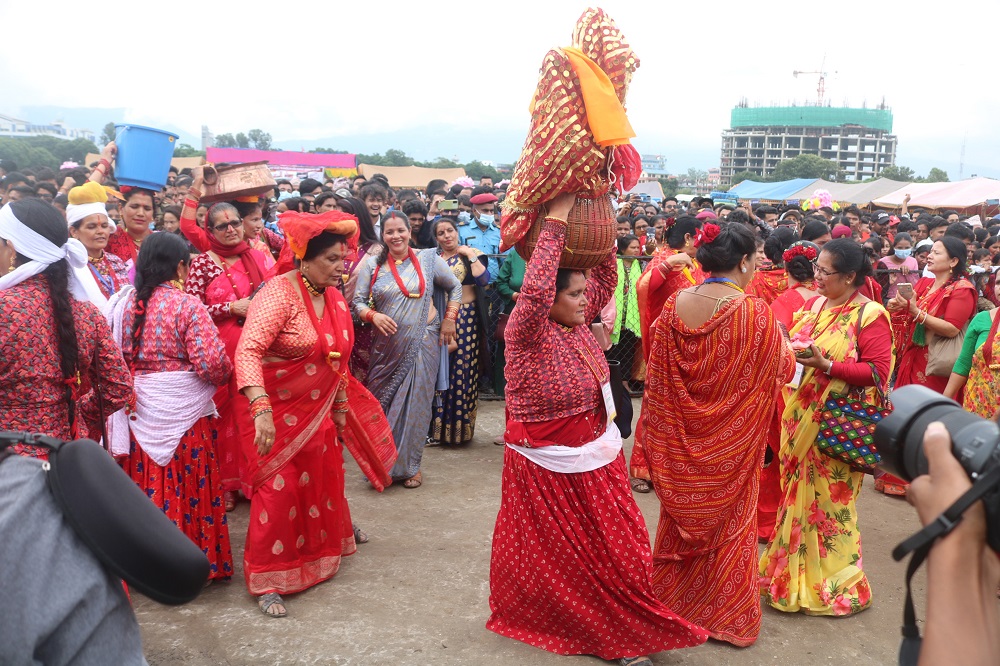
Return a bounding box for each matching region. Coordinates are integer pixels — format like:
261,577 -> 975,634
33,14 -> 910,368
118,417 -> 233,579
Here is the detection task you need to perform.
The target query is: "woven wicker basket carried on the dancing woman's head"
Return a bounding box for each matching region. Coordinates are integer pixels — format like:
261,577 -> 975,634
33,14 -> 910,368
517,194 -> 618,271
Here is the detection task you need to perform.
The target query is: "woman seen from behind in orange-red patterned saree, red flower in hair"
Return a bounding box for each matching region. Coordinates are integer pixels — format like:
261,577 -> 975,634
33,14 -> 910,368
644,222 -> 795,647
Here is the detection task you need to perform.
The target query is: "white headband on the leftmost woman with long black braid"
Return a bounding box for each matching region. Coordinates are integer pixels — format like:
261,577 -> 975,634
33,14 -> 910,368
0,204 -> 108,308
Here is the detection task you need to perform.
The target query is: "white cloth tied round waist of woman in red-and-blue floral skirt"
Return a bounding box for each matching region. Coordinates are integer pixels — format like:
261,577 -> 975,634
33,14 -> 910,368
108,371 -> 218,467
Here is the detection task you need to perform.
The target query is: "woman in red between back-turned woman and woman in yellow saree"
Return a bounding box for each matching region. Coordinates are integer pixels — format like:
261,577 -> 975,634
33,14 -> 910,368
751,241 -> 819,543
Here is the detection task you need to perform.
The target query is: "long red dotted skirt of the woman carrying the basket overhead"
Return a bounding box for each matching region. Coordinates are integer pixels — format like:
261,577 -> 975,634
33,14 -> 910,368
486,448 -> 708,659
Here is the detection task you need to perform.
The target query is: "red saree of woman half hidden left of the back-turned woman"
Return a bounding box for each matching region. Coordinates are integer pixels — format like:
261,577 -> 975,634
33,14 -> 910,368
628,250 -> 708,481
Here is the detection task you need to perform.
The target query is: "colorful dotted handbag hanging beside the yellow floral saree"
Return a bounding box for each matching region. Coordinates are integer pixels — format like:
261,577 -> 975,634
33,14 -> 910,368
816,363 -> 892,474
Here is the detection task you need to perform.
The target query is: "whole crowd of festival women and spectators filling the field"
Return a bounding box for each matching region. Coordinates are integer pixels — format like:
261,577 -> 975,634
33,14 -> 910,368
0,144 -> 1000,664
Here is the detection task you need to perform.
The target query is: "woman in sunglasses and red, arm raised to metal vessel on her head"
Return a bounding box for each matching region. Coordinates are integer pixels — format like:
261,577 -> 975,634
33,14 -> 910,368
181,196 -> 266,511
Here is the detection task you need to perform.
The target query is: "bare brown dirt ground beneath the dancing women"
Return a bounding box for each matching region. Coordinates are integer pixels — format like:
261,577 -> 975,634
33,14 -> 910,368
135,401 -> 925,666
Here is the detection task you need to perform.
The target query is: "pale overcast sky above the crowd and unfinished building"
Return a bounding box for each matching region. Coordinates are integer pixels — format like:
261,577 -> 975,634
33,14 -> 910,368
0,0 -> 1000,180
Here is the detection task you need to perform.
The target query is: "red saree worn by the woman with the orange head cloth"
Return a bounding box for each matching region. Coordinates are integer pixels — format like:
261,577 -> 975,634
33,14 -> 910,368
243,278 -> 395,595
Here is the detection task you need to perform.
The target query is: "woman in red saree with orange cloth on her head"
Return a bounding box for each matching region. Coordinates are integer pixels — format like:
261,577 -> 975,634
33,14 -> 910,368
236,211 -> 396,617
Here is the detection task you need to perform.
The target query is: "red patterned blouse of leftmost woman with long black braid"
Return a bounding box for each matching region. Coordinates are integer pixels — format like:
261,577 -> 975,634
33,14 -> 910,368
0,275 -> 132,448
